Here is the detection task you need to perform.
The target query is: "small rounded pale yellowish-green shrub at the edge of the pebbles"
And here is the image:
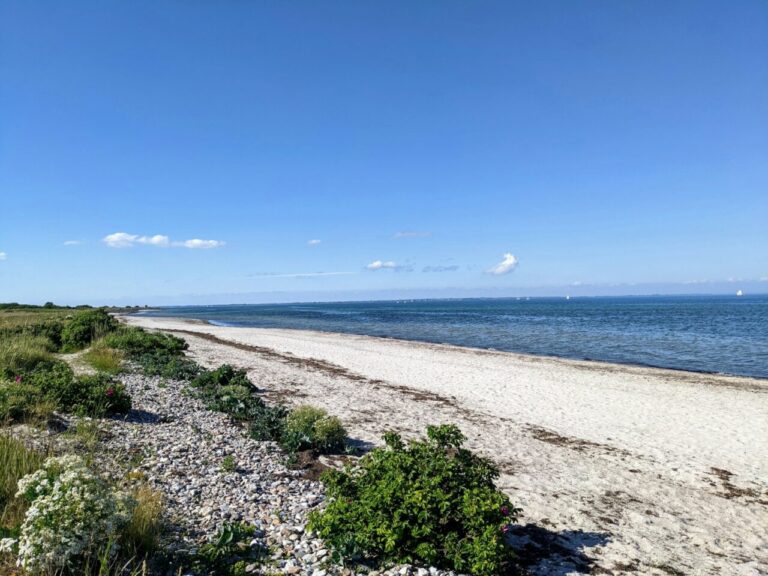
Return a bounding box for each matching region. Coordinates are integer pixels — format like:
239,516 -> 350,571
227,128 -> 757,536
282,406 -> 347,453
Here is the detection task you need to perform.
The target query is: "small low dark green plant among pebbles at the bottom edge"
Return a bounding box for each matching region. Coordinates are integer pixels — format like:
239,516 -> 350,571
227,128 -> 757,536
194,522 -> 266,576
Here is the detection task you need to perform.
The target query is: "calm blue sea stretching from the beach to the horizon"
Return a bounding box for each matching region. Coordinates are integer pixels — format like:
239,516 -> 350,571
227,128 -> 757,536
146,295 -> 768,378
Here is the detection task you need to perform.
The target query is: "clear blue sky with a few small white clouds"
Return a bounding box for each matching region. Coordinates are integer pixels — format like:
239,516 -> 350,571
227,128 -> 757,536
0,0 -> 768,305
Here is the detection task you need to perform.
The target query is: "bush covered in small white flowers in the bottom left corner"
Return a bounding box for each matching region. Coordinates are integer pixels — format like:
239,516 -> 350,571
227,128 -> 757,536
3,455 -> 130,574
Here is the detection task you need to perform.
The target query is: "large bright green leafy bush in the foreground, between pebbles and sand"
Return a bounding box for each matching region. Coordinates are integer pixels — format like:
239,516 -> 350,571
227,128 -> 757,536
310,425 -> 519,576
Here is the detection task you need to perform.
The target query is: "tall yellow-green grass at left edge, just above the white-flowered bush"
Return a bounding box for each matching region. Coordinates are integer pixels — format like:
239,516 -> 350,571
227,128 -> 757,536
0,434 -> 45,532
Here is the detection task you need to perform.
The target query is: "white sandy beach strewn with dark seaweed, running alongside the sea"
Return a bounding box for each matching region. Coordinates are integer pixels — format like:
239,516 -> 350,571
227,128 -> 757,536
126,316 -> 768,575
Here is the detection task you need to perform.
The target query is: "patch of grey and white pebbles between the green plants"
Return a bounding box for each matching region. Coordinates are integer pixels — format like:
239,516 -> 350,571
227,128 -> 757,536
100,374 -> 464,576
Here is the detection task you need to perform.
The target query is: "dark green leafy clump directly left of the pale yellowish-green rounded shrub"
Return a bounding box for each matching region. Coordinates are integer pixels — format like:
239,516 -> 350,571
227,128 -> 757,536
191,364 -> 288,440
